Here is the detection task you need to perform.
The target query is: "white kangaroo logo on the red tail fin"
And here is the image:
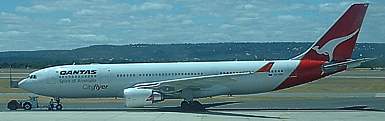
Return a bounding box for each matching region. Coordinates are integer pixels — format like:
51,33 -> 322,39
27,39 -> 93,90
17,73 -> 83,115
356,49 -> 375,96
311,29 -> 359,61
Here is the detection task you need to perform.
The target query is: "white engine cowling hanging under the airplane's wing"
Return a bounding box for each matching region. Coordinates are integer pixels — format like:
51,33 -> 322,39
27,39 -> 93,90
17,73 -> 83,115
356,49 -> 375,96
124,88 -> 164,107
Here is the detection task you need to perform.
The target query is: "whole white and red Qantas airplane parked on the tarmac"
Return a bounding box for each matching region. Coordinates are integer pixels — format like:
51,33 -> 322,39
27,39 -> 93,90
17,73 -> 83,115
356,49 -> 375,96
18,3 -> 371,110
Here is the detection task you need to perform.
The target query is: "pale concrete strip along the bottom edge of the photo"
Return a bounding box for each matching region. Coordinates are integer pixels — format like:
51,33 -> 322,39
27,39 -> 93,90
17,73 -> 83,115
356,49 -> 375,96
0,110 -> 385,121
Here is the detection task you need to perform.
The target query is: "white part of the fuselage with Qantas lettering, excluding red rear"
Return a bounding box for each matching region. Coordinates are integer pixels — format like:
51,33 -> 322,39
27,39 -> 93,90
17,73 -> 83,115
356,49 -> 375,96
19,60 -> 300,98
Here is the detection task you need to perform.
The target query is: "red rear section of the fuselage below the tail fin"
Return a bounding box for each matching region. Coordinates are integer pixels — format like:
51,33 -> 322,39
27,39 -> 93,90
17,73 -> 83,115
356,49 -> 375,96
274,60 -> 325,90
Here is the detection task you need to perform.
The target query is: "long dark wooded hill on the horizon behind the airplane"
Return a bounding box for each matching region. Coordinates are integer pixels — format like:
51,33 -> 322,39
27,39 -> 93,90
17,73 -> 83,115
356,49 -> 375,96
0,42 -> 385,68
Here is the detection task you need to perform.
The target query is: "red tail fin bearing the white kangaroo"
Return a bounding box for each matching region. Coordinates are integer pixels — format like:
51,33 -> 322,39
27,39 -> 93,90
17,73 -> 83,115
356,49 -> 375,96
293,3 -> 368,62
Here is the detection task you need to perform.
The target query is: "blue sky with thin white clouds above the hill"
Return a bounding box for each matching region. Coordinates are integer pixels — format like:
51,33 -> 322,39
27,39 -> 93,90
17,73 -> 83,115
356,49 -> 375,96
0,0 -> 385,51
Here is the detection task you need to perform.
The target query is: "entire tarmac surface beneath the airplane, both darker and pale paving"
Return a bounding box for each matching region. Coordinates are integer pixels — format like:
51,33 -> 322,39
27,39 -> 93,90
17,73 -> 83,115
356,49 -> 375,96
0,93 -> 385,121
